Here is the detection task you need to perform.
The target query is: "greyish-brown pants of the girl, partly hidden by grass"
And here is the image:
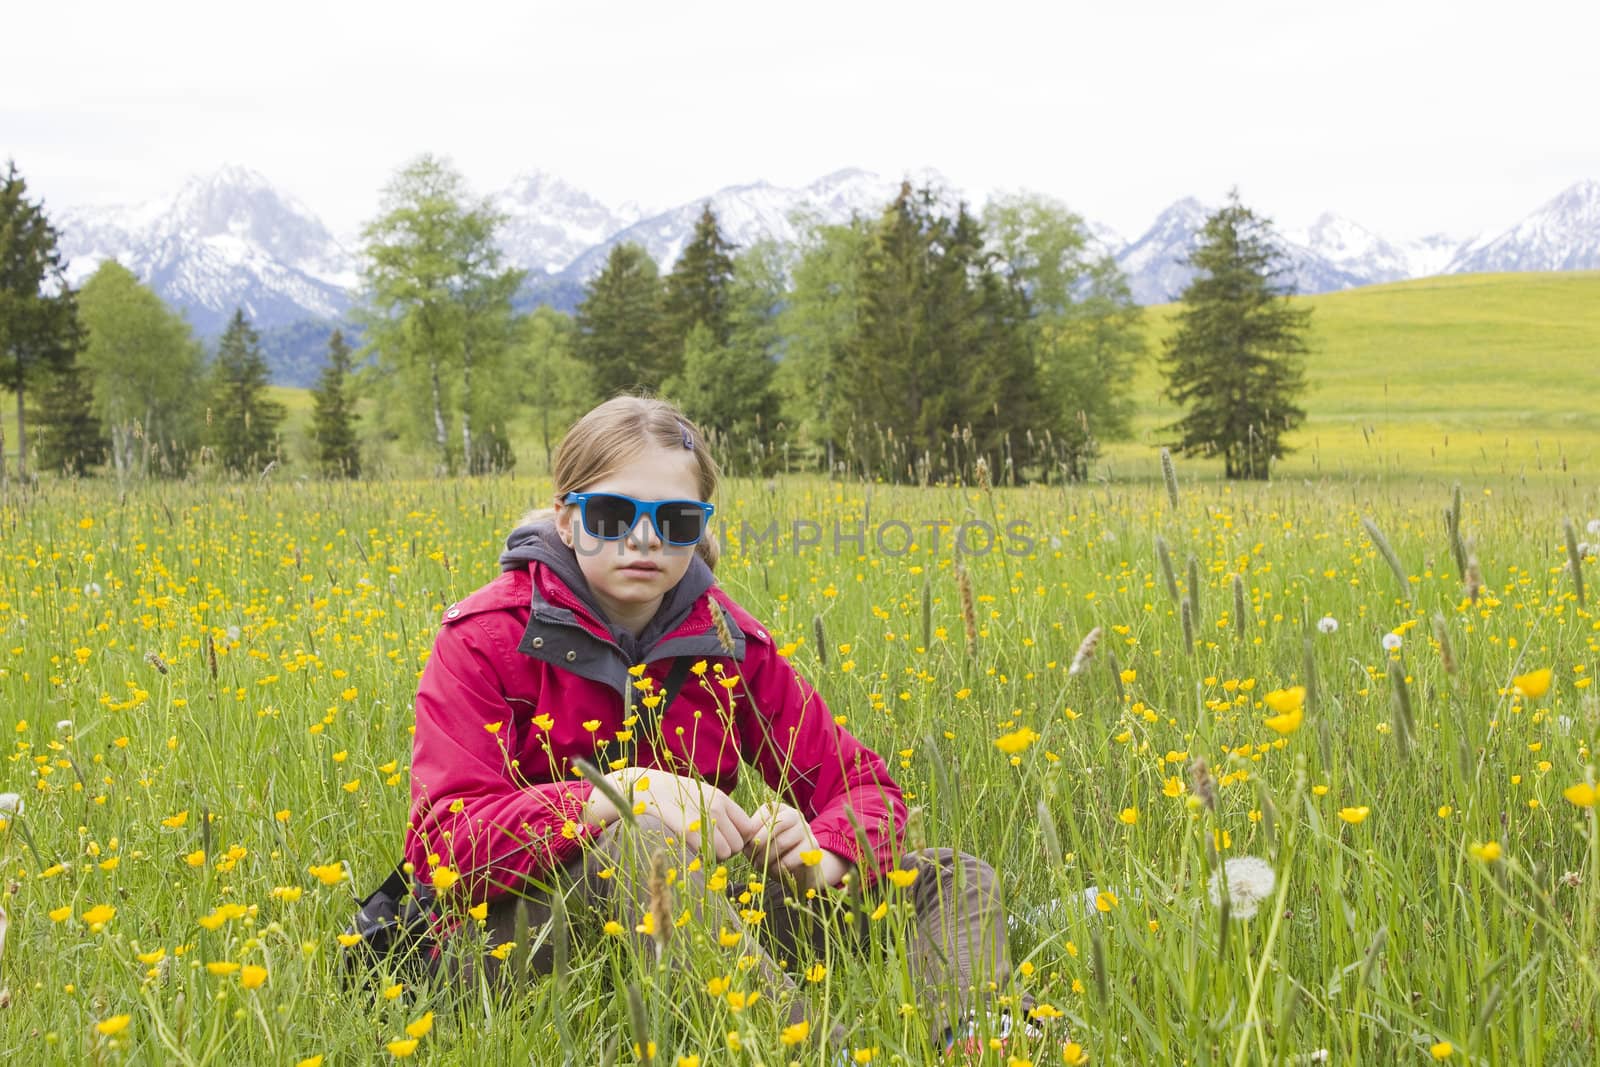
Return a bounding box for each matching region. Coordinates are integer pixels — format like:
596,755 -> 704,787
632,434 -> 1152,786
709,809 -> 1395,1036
443,816 -> 1011,1040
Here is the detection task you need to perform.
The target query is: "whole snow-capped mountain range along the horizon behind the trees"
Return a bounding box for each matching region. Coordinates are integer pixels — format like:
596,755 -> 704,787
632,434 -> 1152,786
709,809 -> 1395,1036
53,166 -> 1600,386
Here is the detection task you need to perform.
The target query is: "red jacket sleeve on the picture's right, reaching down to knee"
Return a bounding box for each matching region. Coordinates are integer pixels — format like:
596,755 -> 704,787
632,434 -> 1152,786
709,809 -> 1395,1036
733,652 -> 906,881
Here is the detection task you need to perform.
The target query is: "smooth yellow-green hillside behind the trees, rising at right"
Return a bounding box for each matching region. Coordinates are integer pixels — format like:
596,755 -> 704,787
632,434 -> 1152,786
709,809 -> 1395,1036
12,270 -> 1600,477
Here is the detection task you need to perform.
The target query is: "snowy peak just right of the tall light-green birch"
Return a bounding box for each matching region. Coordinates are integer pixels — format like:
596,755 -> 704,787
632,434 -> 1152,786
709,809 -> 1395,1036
493,171 -> 640,274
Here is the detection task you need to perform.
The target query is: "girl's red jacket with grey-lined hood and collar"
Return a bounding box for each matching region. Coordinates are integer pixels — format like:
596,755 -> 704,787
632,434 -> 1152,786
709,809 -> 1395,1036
405,561 -> 906,901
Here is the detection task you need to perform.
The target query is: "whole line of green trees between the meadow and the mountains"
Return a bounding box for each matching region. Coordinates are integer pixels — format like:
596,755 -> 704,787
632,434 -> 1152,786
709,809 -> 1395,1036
0,155 -> 1307,483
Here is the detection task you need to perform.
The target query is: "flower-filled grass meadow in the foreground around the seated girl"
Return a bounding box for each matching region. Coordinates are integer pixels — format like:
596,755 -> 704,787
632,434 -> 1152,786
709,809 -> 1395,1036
0,462 -> 1600,1065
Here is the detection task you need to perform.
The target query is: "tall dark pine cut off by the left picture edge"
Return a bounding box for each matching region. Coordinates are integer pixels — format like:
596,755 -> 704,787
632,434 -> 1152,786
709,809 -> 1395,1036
0,162 -> 82,475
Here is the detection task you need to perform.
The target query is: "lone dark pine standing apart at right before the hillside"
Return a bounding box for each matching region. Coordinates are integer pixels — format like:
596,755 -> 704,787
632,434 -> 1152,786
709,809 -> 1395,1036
1162,192 -> 1310,478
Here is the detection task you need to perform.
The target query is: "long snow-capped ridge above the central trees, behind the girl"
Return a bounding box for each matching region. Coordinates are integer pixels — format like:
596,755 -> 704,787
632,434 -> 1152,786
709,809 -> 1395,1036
563,170 -> 962,282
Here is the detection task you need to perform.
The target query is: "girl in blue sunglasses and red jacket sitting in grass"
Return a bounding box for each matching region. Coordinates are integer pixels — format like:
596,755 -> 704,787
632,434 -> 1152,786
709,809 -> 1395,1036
406,397 -> 1043,1062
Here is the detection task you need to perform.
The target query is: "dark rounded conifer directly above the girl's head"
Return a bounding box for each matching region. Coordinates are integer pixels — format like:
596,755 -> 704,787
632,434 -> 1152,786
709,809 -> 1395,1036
573,243 -> 669,398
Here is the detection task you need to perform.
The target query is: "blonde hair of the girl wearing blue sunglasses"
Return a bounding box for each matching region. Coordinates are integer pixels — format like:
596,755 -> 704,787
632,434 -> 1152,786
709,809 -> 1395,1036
522,397 -> 722,568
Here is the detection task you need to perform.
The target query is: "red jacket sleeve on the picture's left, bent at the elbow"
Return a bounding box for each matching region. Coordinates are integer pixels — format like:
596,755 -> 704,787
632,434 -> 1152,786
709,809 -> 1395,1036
405,616 -> 592,901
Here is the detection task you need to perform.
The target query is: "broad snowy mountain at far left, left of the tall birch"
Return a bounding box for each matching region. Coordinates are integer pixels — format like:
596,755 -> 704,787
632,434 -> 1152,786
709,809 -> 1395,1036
58,166 -> 355,336
